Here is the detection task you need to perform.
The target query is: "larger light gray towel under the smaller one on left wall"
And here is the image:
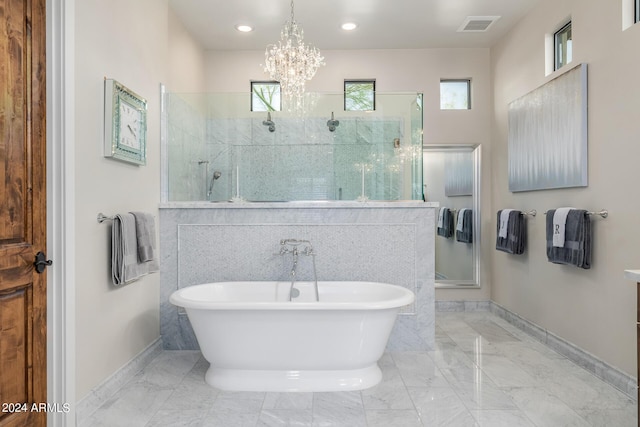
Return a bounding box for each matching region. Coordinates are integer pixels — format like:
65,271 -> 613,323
111,214 -> 158,286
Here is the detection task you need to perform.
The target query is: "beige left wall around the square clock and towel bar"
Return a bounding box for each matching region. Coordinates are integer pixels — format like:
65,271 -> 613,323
74,0 -> 168,400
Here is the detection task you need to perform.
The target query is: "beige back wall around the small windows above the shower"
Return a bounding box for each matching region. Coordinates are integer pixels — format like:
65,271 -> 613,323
206,49 -> 493,301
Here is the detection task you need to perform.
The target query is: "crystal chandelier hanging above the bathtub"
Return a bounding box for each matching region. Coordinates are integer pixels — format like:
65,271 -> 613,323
264,0 -> 324,111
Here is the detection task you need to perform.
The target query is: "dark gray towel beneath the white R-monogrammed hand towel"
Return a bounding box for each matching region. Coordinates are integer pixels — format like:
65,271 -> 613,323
546,209 -> 591,269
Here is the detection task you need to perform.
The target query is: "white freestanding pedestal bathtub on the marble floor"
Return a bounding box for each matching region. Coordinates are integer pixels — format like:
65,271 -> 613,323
170,281 -> 415,391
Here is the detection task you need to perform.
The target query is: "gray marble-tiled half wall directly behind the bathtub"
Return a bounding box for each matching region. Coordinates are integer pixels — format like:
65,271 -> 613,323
160,202 -> 435,350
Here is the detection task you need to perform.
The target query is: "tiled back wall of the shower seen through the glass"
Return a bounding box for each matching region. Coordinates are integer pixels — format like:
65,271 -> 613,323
212,117 -> 404,201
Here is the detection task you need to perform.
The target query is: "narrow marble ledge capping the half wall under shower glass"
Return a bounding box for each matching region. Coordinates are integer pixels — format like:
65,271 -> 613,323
159,200 -> 440,209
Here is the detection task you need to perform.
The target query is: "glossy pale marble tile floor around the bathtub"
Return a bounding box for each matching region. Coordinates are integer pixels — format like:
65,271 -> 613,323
81,312 -> 638,427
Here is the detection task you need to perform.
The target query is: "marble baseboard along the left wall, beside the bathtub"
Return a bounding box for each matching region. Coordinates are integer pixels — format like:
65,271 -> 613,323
76,338 -> 162,426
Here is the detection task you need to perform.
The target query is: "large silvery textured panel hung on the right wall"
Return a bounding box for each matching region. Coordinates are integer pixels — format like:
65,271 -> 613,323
509,64 -> 587,192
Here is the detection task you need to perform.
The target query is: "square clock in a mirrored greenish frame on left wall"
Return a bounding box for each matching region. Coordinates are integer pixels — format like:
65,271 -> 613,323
104,79 -> 147,165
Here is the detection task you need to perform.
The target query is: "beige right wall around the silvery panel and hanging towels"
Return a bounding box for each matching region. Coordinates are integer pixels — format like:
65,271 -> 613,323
490,0 -> 640,375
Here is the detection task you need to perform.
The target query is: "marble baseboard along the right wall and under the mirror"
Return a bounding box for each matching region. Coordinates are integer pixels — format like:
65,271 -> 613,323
435,301 -> 638,402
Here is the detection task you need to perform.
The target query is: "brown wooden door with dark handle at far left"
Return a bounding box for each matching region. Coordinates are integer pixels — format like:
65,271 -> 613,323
0,0 -> 47,426
